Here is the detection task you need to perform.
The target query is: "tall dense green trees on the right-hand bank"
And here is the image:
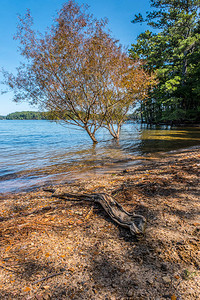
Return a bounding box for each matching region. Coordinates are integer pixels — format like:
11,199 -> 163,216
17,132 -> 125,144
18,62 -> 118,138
129,0 -> 200,123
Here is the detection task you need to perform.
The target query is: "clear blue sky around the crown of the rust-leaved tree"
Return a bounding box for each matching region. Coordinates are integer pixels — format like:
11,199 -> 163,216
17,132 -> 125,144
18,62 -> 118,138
0,0 -> 152,115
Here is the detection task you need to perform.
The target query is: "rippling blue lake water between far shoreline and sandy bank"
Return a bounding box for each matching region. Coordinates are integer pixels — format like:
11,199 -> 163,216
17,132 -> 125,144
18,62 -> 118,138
0,120 -> 200,193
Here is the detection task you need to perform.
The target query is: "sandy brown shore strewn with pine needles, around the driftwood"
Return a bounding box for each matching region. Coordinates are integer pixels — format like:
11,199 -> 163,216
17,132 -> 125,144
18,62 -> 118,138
0,148 -> 200,300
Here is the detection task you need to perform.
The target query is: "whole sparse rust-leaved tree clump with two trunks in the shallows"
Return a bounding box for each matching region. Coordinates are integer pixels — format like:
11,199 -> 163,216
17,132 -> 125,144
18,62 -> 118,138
1,0 -> 153,143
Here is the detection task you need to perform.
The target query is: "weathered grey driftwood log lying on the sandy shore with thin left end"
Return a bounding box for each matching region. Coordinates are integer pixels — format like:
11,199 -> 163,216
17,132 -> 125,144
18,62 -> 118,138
46,189 -> 146,235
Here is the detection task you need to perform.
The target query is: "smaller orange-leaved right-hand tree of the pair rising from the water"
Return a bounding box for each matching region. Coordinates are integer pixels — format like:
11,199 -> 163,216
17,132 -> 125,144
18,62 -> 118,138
101,57 -> 156,139
